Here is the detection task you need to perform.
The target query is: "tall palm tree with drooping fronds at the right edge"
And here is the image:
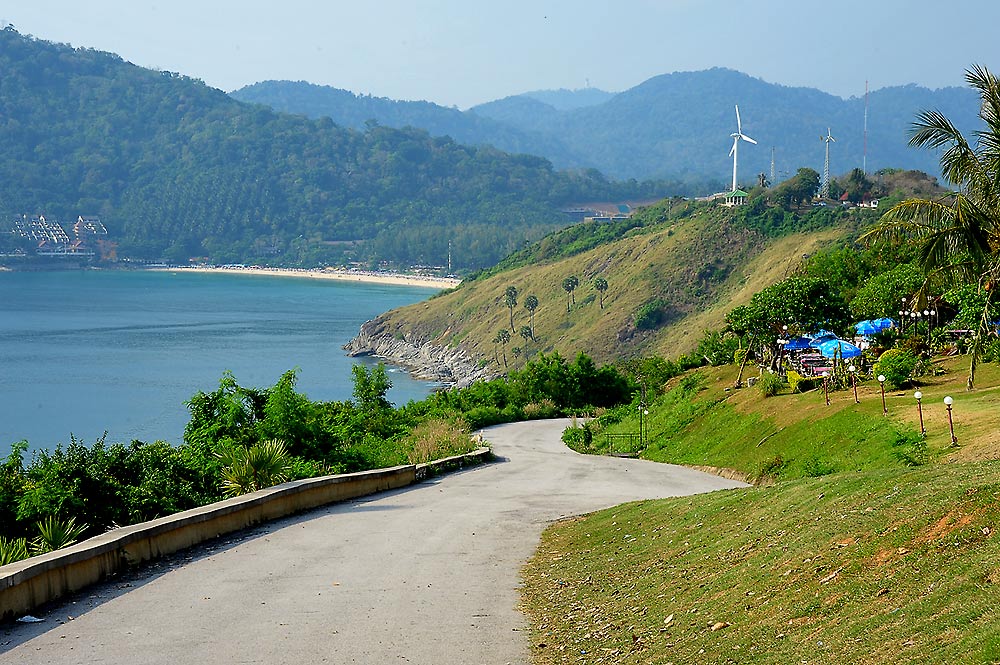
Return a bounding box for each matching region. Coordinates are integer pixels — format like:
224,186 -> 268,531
862,65 -> 1000,390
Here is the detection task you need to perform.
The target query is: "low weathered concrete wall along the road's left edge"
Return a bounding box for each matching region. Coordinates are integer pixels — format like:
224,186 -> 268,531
0,448 -> 491,621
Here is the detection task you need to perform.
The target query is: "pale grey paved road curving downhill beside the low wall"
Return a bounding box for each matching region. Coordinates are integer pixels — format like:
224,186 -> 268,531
0,421 -> 740,665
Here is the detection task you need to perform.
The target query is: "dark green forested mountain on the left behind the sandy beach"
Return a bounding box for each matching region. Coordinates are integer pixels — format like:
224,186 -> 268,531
0,27 -> 677,269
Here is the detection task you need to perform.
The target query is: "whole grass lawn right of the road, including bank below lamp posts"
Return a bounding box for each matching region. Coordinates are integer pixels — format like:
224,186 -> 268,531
523,359 -> 1000,664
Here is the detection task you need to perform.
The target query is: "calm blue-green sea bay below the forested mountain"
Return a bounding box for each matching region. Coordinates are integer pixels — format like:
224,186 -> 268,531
0,270 -> 439,457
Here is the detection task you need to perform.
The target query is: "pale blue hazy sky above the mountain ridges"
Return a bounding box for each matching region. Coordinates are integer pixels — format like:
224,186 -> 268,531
0,0 -> 1000,109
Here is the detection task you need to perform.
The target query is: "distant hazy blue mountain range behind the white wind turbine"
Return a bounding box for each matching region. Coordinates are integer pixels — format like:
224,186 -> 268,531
233,68 -> 977,184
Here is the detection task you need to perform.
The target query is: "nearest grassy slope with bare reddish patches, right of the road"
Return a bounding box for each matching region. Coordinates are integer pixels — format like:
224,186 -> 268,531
524,462 -> 1000,665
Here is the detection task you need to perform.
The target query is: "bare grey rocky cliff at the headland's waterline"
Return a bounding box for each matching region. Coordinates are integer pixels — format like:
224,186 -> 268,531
344,314 -> 496,387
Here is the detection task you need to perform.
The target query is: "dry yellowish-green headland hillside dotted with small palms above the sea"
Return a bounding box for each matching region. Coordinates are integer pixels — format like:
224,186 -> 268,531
364,201 -> 849,371
